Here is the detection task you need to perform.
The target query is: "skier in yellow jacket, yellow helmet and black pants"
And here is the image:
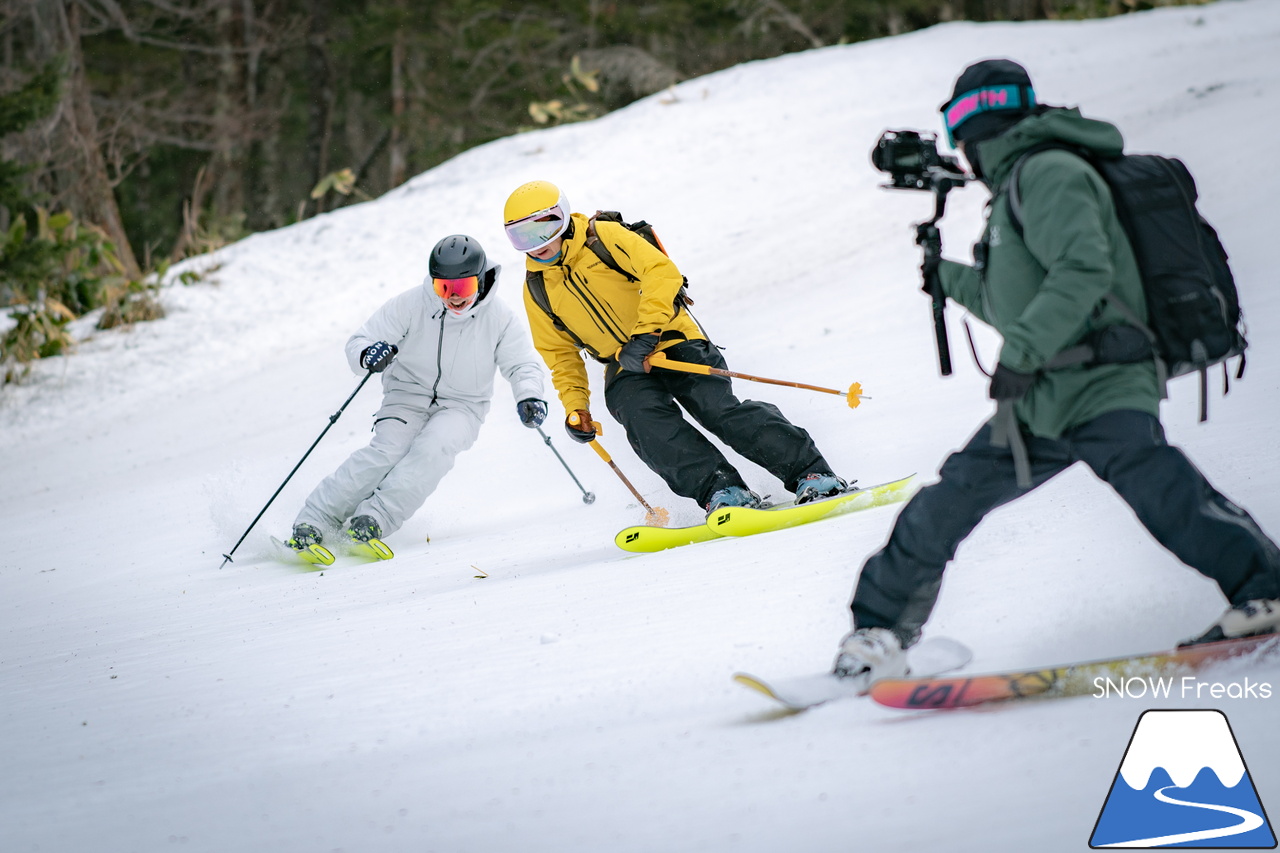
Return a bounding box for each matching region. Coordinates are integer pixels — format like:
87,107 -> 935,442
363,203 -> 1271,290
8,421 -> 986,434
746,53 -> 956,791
504,181 -> 850,512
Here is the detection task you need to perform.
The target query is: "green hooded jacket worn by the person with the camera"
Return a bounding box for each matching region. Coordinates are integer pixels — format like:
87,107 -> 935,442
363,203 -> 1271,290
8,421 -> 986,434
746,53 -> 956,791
940,108 -> 1164,438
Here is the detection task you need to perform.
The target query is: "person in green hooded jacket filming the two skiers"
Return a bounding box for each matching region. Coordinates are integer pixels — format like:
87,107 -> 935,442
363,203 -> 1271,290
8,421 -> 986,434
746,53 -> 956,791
833,59 -> 1280,684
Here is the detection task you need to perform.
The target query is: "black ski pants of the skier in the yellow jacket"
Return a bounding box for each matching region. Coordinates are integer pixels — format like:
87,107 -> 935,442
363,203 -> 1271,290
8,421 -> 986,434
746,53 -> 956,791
604,341 -> 831,506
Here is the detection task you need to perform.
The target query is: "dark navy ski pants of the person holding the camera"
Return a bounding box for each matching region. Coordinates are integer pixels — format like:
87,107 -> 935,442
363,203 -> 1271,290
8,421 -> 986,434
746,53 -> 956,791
851,410 -> 1280,643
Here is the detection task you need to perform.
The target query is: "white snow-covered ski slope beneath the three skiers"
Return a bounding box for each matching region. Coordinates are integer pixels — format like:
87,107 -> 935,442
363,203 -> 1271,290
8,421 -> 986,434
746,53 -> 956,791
0,0 -> 1280,853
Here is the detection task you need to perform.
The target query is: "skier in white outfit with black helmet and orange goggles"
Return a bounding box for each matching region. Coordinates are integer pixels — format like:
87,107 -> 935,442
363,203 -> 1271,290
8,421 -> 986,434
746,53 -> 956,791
287,234 -> 547,553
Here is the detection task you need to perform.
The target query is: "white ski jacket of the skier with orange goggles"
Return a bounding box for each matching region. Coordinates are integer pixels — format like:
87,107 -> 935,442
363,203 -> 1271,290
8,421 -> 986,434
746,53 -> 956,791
347,265 -> 545,421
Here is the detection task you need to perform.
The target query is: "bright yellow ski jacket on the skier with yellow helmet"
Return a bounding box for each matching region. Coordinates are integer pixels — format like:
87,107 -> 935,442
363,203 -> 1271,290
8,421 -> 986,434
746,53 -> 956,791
525,213 -> 705,412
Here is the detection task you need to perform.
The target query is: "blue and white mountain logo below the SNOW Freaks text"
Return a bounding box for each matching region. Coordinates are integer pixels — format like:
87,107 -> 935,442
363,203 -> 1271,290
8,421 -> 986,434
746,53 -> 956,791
1089,711 -> 1276,849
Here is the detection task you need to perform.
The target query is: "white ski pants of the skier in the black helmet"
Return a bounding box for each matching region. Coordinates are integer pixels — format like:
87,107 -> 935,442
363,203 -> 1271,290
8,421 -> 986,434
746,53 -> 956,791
294,403 -> 480,537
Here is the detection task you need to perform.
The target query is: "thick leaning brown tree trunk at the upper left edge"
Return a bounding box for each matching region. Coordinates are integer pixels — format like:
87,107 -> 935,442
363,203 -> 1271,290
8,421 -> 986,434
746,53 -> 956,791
33,0 -> 141,278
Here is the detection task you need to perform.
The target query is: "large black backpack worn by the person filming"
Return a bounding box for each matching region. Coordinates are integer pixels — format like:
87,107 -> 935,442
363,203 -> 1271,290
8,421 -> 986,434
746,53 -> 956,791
1009,143 -> 1248,420
